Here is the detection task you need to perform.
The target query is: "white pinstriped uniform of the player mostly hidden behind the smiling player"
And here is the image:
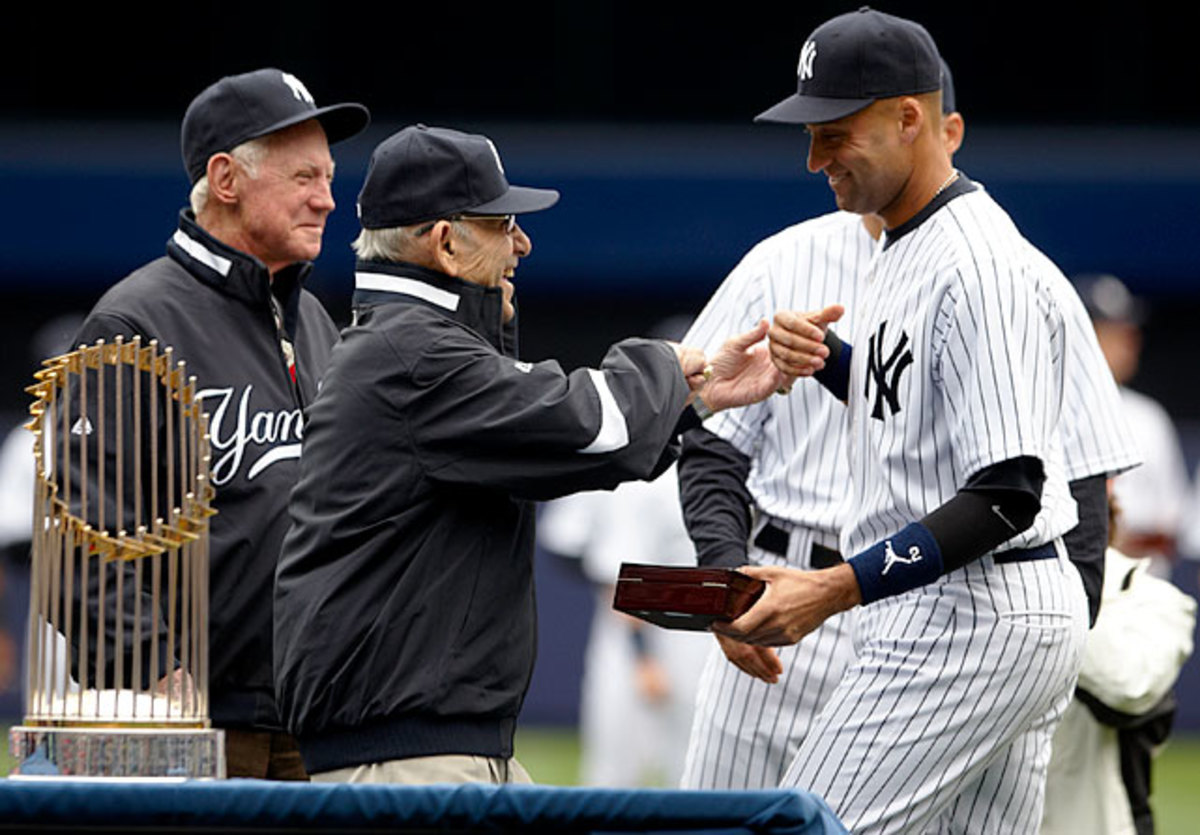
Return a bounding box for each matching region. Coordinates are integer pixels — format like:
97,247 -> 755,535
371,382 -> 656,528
683,196 -> 1136,788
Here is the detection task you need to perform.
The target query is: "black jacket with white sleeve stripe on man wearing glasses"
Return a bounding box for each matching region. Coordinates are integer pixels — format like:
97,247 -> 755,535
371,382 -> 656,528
275,263 -> 690,771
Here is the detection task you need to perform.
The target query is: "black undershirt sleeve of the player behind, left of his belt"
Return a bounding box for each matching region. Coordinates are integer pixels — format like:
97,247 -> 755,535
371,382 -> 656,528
679,427 -> 752,569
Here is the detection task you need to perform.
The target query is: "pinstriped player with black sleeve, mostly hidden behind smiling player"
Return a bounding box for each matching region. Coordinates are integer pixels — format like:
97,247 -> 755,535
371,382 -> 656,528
680,212 -> 875,788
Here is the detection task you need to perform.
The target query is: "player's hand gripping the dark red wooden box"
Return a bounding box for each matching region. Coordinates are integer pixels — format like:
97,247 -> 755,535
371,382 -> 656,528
713,564 -> 863,647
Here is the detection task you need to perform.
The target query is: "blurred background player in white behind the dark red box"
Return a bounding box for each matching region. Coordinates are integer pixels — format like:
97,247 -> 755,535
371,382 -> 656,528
538,316 -> 712,787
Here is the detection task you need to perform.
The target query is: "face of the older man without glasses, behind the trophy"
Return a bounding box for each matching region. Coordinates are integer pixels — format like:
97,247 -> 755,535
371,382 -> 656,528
238,120 -> 334,272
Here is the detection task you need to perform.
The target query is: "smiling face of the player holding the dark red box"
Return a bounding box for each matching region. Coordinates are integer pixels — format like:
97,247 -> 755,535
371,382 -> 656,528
805,98 -> 911,215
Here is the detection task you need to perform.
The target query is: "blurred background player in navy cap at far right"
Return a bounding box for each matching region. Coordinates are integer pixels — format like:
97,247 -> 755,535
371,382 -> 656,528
1073,275 -> 1190,578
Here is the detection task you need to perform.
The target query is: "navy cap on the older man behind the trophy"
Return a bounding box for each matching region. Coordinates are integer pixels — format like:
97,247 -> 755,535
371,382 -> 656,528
180,67 -> 371,184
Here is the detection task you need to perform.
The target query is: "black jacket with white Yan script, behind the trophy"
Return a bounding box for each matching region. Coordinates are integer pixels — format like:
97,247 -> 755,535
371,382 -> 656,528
74,211 -> 337,728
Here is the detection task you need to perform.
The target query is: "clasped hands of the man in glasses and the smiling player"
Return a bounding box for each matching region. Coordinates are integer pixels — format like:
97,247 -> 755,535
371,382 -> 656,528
670,305 -> 844,412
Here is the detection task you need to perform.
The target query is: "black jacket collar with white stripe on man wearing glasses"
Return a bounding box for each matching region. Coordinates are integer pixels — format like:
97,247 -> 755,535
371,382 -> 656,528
354,260 -> 517,356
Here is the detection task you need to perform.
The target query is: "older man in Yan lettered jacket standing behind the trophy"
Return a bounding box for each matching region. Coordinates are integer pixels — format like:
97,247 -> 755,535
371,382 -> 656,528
68,68 -> 370,780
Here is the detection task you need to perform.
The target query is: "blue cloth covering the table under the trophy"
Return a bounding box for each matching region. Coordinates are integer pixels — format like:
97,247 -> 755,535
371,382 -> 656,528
0,779 -> 846,835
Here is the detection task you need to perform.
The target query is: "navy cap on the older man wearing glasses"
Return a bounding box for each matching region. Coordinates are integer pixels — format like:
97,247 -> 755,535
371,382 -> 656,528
359,125 -> 558,229
